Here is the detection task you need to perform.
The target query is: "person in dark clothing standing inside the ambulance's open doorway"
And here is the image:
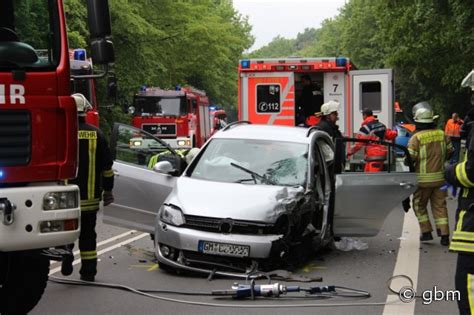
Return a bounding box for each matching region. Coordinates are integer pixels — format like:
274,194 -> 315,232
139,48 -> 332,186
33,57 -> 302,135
297,74 -> 323,125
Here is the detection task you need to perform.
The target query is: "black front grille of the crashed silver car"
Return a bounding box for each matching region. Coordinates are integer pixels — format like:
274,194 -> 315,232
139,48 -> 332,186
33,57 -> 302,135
184,215 -> 275,235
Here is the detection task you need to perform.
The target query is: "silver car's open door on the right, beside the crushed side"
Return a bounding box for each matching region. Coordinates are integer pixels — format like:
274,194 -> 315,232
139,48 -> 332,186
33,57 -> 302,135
333,138 -> 417,236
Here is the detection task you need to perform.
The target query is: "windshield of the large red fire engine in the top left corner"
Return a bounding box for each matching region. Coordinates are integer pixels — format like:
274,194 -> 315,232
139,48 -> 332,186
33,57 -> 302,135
0,0 -> 61,71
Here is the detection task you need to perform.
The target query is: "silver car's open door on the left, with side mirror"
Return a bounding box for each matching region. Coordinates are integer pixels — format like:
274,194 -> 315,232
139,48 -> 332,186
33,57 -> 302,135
103,123 -> 184,233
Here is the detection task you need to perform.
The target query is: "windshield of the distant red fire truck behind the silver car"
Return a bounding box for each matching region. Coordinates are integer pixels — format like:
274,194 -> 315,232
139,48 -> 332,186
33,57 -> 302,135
134,96 -> 186,116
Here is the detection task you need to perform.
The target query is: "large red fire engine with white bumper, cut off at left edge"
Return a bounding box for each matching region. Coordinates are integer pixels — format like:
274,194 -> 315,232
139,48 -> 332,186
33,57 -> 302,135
0,0 -> 113,314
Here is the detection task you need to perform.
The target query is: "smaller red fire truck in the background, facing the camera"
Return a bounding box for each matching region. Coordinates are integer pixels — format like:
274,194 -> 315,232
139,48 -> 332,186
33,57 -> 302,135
129,87 -> 211,149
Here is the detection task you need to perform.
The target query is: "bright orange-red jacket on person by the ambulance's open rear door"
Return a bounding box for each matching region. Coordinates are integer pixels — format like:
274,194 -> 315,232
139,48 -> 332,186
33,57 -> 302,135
349,116 -> 397,162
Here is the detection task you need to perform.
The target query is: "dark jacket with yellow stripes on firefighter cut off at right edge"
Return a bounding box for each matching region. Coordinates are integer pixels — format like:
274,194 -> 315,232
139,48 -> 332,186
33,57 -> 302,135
446,155 -> 474,254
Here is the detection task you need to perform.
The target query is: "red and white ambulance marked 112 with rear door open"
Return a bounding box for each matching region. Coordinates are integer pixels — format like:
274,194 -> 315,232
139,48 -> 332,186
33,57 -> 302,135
238,57 -> 395,136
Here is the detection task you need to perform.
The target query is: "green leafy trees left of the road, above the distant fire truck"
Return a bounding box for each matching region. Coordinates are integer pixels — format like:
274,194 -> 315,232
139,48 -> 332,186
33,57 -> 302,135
65,0 -> 253,133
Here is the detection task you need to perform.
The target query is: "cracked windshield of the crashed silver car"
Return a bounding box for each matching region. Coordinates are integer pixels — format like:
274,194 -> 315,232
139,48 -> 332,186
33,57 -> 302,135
190,139 -> 308,186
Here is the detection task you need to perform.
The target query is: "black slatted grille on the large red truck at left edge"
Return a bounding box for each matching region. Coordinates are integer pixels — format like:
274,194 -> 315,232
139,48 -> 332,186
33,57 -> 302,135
0,110 -> 31,166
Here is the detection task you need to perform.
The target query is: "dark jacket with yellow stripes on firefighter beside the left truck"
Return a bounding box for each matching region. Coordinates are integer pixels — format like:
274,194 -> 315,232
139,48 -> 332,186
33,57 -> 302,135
71,121 -> 114,211
